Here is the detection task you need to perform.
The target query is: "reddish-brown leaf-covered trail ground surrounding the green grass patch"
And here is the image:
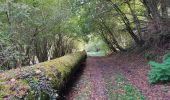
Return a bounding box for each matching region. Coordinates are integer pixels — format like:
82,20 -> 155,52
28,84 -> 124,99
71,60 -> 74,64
65,56 -> 170,100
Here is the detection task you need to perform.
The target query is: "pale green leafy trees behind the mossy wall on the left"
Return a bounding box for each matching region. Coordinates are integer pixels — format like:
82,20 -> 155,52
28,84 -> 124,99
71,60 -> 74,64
0,0 -> 85,69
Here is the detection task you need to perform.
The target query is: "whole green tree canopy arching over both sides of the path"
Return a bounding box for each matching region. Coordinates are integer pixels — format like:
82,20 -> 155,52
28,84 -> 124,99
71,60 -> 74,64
0,0 -> 170,69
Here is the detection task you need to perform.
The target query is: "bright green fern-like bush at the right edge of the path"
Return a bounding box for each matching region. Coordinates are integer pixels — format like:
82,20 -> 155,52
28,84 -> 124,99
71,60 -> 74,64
148,52 -> 170,83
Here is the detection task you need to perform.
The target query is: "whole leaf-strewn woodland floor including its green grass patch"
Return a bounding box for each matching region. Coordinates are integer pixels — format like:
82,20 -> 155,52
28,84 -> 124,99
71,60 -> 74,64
63,51 -> 170,100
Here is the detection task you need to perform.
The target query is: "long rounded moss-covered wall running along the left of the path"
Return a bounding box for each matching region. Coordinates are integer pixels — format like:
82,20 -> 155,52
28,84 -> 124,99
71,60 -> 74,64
0,52 -> 86,100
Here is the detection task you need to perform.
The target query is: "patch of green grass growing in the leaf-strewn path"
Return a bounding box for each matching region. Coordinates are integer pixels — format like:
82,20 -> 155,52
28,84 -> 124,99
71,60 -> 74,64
105,73 -> 145,100
